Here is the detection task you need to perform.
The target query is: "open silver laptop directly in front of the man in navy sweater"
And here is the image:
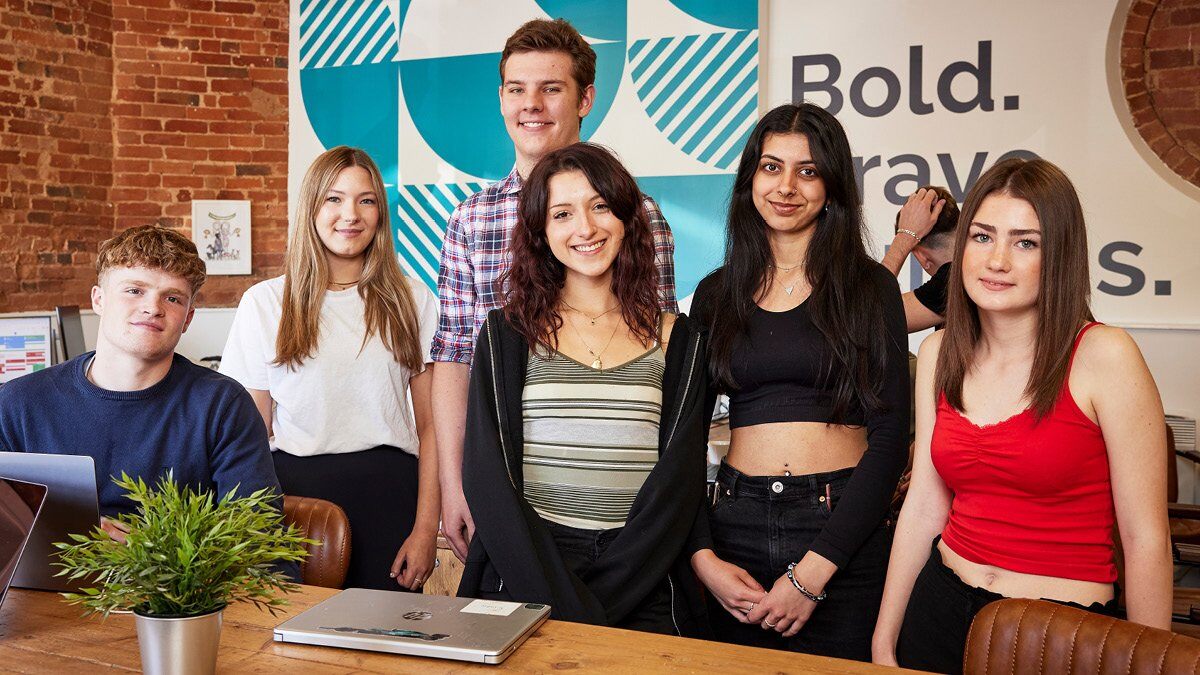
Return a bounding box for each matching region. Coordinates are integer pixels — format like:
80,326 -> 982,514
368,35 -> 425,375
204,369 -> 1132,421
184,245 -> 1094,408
0,452 -> 100,591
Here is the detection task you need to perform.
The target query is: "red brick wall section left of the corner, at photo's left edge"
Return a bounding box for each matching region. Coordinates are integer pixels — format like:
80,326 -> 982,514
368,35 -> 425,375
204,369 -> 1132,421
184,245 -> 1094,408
0,0 -> 113,311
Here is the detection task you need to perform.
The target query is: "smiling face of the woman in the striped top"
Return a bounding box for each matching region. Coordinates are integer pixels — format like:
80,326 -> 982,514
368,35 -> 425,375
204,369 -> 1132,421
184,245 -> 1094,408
546,171 -> 625,282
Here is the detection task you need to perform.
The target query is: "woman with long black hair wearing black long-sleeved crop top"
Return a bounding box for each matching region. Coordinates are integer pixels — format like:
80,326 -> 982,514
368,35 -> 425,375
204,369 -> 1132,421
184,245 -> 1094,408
692,104 -> 910,661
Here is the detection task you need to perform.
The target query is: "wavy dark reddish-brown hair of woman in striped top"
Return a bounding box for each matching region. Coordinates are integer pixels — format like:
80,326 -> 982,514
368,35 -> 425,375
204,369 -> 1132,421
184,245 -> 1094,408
499,143 -> 659,350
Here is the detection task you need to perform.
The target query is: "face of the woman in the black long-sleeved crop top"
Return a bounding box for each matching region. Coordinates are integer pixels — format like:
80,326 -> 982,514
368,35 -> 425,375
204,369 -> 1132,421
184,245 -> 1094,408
751,133 -> 826,233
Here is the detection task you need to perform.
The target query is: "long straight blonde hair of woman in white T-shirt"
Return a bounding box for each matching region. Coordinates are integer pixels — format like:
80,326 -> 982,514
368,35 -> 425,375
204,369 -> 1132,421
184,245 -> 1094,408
275,145 -> 424,371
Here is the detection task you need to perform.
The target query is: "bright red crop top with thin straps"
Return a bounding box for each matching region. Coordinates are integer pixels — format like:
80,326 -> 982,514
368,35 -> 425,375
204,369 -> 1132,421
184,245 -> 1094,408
930,323 -> 1117,584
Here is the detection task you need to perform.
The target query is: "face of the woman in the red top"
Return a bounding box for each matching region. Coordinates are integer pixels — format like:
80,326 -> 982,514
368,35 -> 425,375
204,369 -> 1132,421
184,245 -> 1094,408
960,192 -> 1042,312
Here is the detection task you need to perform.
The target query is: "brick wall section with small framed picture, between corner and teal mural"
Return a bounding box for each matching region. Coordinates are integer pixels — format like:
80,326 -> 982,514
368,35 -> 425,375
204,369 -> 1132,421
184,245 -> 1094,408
112,0 -> 288,306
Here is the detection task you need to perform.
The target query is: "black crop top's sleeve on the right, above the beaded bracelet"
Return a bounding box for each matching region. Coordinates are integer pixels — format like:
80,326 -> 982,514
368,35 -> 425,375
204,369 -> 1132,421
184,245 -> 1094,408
811,260 -> 912,568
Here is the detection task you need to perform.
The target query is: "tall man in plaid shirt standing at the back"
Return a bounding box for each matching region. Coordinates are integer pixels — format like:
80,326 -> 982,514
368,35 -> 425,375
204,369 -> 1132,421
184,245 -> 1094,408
432,19 -> 677,558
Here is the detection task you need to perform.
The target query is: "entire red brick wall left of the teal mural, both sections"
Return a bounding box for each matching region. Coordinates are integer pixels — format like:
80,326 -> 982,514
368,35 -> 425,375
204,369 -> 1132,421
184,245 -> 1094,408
0,0 -> 288,311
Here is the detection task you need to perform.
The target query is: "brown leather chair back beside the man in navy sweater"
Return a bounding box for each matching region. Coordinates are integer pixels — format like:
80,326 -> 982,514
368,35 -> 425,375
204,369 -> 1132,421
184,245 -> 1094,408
283,495 -> 350,589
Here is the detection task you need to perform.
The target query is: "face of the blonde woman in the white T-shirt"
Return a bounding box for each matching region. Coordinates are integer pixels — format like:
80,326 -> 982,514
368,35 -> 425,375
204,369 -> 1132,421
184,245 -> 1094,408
316,166 -> 379,264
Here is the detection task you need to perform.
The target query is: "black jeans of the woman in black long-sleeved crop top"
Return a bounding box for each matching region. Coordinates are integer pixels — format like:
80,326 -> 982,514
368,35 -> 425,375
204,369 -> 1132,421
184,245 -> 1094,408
708,464 -> 892,661
